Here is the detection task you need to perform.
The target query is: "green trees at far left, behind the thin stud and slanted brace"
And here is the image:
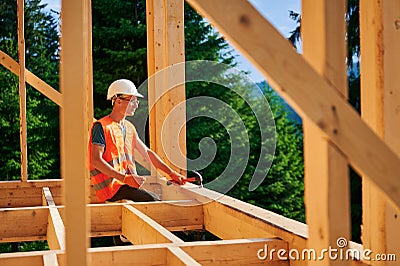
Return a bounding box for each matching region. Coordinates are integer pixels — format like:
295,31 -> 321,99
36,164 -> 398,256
0,0 -> 60,180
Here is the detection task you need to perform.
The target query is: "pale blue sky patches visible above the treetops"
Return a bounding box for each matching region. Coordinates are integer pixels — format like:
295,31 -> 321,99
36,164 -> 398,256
42,0 -> 301,82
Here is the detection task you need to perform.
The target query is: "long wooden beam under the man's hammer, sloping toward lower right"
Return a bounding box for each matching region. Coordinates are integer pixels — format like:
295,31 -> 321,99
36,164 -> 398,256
160,182 -> 308,248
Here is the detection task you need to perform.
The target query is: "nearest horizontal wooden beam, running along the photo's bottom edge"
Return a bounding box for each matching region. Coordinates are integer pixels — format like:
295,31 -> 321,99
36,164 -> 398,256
0,239 -> 288,266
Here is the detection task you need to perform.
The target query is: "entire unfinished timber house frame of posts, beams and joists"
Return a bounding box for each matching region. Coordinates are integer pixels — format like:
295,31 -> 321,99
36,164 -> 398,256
0,0 -> 400,265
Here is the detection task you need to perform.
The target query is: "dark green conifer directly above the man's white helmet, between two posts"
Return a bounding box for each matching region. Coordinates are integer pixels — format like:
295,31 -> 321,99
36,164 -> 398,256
92,0 -> 147,118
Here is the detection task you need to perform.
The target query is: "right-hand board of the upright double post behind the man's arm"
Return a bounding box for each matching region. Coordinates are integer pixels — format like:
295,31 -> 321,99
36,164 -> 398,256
160,0 -> 186,174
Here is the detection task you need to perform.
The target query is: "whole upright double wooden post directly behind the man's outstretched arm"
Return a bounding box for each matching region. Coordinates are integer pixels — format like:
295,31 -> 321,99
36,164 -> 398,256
146,0 -> 186,177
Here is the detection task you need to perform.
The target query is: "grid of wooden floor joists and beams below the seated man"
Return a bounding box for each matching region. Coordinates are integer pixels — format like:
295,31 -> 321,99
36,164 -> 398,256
0,178 -> 376,265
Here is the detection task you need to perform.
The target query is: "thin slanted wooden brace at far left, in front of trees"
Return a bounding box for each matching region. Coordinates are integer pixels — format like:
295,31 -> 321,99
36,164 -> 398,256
0,50 -> 63,107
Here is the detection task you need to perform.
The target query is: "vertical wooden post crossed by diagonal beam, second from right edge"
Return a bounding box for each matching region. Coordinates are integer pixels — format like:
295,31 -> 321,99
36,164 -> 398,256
302,0 -> 351,265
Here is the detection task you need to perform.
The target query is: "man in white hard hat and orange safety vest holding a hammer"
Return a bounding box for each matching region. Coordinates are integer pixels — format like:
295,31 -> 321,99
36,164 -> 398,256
89,79 -> 184,202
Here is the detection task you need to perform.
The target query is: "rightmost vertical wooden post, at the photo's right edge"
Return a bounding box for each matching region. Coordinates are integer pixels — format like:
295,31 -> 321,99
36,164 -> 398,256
360,0 -> 400,265
